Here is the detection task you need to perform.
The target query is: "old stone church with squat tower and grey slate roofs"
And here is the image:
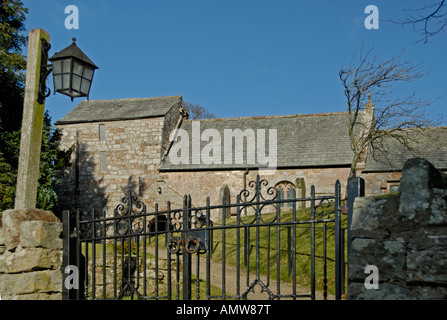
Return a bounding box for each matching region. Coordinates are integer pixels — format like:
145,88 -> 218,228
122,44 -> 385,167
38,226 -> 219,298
56,96 -> 447,216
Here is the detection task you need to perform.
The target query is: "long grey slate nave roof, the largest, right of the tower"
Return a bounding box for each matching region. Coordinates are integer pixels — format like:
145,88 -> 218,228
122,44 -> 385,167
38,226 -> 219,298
160,112 -> 353,171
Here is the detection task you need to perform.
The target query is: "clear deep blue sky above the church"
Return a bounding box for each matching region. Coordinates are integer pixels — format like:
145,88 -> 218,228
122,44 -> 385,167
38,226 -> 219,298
23,0 -> 447,121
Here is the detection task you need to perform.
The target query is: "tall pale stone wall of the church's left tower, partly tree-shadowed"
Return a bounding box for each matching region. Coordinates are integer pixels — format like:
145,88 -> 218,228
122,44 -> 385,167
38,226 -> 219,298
57,117 -> 176,209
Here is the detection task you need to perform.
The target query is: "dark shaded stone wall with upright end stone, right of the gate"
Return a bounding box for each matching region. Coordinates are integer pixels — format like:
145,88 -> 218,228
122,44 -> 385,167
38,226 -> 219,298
347,158 -> 447,300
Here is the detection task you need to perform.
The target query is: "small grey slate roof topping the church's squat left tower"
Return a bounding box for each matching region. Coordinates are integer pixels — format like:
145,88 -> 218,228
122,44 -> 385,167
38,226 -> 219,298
56,96 -> 182,124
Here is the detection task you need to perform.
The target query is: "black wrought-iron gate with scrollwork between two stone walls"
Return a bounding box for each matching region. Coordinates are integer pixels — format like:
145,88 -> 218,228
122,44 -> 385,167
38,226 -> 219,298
63,176 -> 346,300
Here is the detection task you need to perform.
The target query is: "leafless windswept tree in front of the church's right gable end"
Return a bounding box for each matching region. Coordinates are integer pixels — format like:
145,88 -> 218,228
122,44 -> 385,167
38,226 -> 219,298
339,48 -> 440,176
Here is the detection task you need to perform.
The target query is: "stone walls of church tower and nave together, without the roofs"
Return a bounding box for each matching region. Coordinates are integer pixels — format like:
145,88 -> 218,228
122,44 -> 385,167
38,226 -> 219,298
57,114 -> 349,221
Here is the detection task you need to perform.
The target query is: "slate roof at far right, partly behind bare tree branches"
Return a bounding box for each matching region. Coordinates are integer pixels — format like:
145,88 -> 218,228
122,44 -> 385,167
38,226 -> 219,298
364,127 -> 447,172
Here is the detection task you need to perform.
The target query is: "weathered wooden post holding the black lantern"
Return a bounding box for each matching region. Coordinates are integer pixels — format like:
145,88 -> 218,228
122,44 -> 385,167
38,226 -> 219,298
14,29 -> 50,209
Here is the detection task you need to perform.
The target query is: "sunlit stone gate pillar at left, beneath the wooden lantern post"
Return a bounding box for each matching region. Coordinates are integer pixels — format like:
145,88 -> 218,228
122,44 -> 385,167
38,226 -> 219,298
0,209 -> 62,300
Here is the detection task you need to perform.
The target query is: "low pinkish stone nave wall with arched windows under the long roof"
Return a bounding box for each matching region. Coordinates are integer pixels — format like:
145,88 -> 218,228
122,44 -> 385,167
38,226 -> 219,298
141,168 -> 349,219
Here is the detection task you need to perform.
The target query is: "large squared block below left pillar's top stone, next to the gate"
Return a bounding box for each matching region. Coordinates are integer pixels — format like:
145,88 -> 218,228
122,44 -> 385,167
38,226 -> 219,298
20,221 -> 62,249
